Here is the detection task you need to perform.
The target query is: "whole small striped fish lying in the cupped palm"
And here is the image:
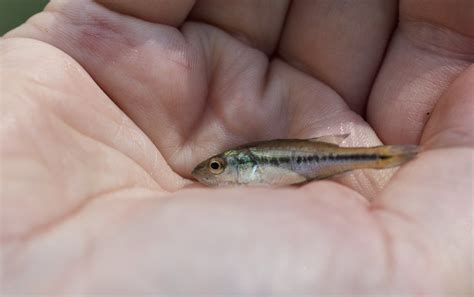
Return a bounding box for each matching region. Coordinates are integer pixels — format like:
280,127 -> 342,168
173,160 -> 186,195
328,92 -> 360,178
192,134 -> 418,186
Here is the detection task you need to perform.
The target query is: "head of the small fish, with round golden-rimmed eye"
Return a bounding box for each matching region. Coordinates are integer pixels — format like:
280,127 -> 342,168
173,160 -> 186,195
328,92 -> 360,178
191,152 -> 239,187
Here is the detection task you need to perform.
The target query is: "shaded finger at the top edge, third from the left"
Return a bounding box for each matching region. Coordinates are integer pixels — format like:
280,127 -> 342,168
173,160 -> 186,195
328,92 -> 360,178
279,0 -> 396,114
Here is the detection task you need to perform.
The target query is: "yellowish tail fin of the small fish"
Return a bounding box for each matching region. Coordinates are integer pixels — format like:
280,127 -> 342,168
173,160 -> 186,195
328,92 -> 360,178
374,145 -> 420,169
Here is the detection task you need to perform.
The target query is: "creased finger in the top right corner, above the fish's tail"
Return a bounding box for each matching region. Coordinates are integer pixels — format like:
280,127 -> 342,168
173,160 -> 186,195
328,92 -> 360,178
367,0 -> 474,143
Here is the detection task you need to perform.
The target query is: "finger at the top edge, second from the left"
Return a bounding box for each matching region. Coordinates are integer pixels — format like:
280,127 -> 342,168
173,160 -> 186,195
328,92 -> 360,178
190,0 -> 289,54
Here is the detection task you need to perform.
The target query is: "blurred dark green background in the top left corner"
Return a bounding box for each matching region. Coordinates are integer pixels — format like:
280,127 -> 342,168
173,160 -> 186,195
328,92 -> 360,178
0,0 -> 48,36
